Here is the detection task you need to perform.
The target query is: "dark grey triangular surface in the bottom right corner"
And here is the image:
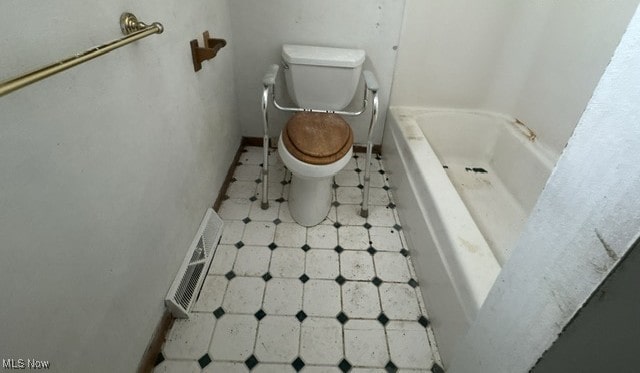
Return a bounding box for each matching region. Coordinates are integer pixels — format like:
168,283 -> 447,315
531,242 -> 640,373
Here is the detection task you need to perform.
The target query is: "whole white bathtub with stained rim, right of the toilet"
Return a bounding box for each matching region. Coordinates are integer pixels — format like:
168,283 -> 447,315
383,107 -> 557,365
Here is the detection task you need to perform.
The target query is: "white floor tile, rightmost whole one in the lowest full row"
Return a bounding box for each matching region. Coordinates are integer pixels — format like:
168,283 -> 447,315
386,321 -> 433,369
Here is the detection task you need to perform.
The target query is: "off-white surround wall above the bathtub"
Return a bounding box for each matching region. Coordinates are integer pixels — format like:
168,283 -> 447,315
391,0 -> 638,155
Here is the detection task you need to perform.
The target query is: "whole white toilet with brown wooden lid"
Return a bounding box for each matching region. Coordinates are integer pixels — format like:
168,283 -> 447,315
278,44 -> 365,227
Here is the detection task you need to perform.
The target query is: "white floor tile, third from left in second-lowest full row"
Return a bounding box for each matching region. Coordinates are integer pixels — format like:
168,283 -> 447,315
262,278 -> 303,315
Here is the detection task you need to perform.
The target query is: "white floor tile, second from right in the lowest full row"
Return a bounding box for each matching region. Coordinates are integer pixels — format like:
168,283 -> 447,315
344,320 -> 389,367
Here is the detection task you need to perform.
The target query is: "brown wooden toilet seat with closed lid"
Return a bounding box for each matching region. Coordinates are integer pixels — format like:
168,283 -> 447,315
282,111 -> 353,165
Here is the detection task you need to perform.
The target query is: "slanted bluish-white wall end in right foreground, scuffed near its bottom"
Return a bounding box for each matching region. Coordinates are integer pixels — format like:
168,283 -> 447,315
448,4 -> 640,373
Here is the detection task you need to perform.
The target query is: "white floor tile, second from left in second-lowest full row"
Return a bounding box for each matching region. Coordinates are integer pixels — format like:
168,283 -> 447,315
222,277 -> 265,314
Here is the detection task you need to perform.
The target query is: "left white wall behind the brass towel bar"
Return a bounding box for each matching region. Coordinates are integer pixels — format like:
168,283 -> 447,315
0,0 -> 240,372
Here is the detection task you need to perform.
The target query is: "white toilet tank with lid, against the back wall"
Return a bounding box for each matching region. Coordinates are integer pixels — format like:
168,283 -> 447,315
282,44 -> 365,110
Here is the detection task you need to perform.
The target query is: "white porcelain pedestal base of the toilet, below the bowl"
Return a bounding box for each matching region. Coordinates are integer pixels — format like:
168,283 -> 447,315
289,173 -> 333,227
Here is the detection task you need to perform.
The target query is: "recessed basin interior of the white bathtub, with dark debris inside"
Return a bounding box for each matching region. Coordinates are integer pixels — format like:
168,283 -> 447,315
416,111 -> 553,265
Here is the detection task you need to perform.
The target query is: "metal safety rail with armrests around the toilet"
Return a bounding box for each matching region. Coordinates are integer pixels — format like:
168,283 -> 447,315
260,64 -> 379,218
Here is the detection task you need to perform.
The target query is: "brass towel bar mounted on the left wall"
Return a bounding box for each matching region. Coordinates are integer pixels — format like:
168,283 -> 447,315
0,13 -> 164,96
